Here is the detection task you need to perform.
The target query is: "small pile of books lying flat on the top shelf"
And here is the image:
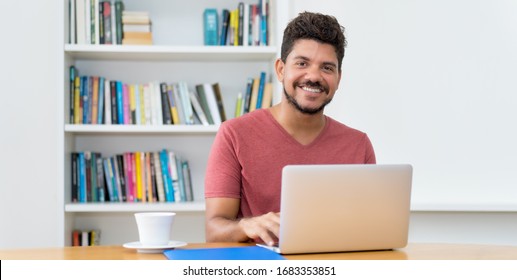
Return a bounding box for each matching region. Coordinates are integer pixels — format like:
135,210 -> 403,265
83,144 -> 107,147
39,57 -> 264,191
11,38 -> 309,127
122,11 -> 153,45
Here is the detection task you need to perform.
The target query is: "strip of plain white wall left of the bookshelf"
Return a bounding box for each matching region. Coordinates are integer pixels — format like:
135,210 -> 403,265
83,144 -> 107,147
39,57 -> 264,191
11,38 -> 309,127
0,0 -> 63,248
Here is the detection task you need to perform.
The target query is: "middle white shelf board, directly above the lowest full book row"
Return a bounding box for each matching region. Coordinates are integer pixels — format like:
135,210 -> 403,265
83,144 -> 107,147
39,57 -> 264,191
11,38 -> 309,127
65,124 -> 219,134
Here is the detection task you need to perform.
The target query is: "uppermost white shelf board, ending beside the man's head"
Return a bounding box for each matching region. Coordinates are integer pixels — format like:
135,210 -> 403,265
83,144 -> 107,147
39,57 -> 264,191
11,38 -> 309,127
65,44 -> 277,62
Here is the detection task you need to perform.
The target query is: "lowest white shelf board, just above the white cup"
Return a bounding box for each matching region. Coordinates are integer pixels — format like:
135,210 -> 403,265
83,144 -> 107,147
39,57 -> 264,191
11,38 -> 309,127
65,202 -> 205,213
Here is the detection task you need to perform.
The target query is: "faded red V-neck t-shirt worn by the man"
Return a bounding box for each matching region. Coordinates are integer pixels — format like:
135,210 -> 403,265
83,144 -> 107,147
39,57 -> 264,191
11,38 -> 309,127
205,109 -> 375,217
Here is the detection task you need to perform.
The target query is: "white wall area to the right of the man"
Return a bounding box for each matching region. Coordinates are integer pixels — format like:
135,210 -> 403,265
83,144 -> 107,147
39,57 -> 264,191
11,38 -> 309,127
291,0 -> 517,244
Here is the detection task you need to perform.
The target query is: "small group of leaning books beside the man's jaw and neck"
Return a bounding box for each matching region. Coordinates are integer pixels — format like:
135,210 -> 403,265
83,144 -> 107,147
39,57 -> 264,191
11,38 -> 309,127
235,71 -> 273,117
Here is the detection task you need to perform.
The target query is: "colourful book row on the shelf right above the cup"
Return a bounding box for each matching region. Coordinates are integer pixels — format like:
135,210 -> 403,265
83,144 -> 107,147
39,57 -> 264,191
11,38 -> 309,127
71,149 -> 194,202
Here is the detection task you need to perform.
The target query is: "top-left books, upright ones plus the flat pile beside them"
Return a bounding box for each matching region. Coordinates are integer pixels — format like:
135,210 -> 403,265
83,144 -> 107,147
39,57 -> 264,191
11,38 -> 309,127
68,0 -> 152,45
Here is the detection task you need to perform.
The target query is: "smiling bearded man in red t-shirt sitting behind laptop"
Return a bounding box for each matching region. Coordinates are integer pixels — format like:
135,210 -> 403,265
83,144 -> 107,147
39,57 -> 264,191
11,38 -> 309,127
205,12 -> 375,245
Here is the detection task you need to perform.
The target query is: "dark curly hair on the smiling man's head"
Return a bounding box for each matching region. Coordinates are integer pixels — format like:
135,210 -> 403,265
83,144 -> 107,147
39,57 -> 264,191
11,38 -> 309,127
280,12 -> 346,71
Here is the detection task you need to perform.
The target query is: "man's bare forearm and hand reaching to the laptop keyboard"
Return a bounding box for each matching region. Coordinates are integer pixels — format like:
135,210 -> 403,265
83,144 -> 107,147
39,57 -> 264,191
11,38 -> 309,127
205,198 -> 280,245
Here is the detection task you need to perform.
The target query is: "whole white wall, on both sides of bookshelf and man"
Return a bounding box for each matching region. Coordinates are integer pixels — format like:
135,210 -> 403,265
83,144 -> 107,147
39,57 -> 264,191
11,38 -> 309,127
0,0 -> 517,248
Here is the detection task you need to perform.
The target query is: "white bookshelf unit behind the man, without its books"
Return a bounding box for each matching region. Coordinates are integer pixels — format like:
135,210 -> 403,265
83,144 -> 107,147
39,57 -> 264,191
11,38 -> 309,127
58,0 -> 288,246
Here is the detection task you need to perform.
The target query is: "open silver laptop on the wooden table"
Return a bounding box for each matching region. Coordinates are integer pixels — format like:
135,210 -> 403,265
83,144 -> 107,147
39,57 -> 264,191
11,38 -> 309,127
260,164 -> 413,254
